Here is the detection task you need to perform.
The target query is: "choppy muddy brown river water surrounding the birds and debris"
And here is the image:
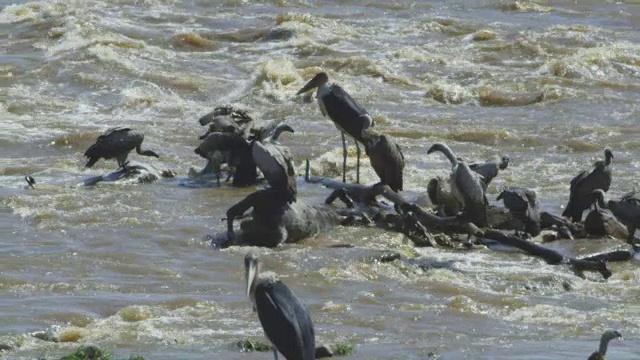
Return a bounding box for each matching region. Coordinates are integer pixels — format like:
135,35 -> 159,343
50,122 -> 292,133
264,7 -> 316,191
0,0 -> 640,360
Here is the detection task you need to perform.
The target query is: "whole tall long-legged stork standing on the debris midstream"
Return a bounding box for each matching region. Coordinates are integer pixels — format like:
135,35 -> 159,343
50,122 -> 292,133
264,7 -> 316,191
296,72 -> 374,183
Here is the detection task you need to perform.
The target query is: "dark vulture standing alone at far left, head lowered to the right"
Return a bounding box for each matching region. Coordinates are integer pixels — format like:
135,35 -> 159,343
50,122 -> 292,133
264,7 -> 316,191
84,128 -> 160,168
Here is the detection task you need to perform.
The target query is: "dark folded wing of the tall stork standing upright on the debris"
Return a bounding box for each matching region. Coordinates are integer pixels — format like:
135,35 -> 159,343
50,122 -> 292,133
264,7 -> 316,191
322,85 -> 373,140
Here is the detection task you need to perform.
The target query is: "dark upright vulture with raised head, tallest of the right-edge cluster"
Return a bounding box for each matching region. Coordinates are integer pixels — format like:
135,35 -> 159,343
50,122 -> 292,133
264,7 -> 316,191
562,149 -> 613,222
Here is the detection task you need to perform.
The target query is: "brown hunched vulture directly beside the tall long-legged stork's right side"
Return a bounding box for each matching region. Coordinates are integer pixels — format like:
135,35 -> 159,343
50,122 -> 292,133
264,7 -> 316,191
362,130 -> 404,192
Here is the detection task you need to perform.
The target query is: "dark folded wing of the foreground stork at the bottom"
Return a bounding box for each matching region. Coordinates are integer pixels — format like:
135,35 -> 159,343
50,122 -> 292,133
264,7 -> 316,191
255,281 -> 315,360
